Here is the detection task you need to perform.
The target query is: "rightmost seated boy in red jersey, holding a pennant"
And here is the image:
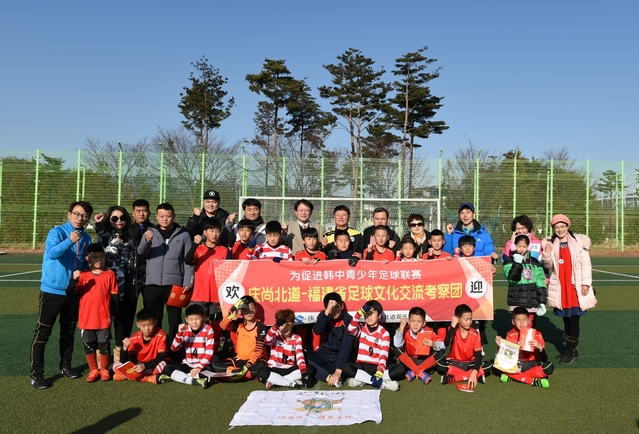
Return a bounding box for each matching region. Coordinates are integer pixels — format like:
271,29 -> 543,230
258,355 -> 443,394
495,307 -> 555,389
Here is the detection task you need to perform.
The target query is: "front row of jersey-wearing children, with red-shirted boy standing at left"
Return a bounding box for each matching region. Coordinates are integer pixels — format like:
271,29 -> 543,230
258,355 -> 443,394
68,244 -> 553,390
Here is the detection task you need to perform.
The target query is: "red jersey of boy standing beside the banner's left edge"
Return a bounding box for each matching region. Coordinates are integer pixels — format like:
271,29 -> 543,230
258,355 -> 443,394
191,244 -> 229,303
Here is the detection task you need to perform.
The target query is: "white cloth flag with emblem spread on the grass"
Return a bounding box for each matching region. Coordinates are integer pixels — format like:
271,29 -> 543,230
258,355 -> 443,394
231,390 -> 382,427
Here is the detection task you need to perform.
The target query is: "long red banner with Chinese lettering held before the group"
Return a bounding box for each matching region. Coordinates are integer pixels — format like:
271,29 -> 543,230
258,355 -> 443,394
215,256 -> 493,324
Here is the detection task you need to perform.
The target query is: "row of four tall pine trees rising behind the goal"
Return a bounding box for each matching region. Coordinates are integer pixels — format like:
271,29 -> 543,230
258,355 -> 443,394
179,47 -> 448,196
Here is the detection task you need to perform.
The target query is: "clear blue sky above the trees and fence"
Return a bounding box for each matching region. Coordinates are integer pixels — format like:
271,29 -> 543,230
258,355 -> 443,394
0,0 -> 639,163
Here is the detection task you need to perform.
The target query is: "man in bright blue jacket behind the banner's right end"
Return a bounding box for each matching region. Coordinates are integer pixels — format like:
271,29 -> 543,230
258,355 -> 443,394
444,202 -> 499,260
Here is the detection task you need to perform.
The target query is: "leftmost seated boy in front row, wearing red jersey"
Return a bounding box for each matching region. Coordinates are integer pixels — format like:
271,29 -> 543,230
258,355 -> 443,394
113,308 -> 168,384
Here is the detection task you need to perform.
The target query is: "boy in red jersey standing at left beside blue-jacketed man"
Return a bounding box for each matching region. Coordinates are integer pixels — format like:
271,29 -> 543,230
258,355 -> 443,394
67,243 -> 118,383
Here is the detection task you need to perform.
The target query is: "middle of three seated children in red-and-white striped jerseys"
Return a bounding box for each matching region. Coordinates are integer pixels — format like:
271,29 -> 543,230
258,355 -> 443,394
257,309 -> 313,389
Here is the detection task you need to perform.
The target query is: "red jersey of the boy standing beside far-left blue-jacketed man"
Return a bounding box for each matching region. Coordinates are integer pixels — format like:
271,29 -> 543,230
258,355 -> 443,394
75,270 -> 118,330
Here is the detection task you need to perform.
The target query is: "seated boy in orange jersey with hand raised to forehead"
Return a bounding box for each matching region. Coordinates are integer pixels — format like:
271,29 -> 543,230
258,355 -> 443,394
213,294 -> 268,381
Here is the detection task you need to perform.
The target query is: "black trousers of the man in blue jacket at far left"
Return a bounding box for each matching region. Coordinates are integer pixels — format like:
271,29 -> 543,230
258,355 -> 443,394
31,292 -> 80,377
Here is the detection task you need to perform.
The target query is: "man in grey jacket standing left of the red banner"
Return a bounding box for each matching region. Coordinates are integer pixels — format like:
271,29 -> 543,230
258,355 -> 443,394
138,203 -> 193,345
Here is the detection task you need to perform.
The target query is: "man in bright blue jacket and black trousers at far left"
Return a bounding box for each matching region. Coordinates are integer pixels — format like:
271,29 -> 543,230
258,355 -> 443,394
31,202 -> 93,389
